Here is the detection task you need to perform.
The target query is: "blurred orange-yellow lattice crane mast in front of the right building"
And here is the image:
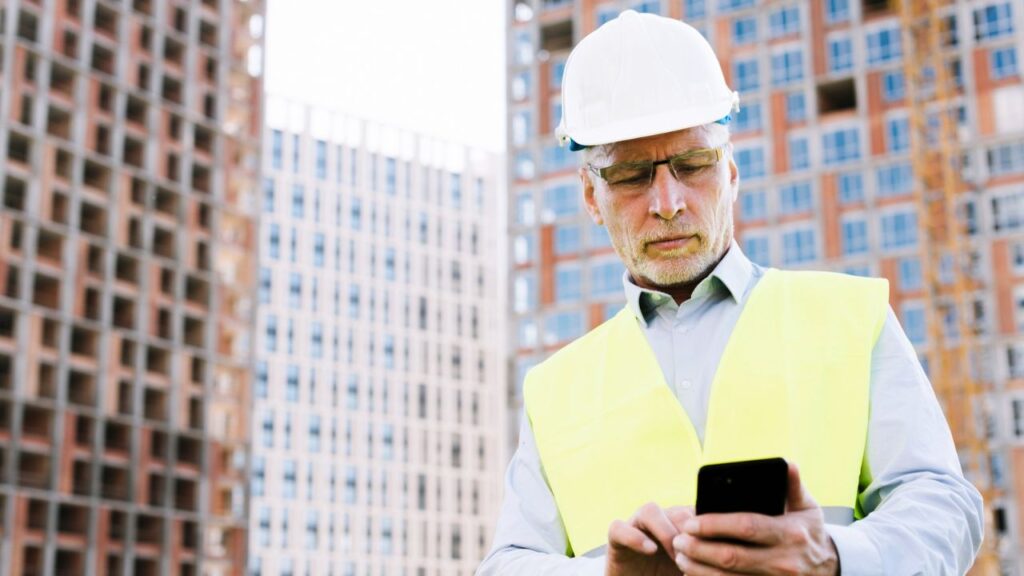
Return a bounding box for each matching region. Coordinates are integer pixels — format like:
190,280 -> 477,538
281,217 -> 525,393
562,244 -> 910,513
899,0 -> 1001,576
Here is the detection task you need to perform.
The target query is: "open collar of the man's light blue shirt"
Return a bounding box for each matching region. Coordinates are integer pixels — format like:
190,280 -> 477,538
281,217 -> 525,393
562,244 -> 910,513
623,240 -> 754,327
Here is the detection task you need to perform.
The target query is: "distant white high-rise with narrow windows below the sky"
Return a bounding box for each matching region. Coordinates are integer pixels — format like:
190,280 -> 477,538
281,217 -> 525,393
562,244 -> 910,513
249,97 -> 506,576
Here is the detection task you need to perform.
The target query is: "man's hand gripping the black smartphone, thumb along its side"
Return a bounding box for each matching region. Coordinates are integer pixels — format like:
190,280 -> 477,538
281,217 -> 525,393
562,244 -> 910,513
673,463 -> 839,576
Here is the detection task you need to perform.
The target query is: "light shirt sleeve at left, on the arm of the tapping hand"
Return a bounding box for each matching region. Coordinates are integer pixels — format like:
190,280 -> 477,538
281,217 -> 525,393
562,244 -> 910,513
476,409 -> 604,576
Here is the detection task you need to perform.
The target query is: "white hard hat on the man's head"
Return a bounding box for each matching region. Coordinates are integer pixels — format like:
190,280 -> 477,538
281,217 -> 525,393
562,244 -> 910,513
555,10 -> 739,150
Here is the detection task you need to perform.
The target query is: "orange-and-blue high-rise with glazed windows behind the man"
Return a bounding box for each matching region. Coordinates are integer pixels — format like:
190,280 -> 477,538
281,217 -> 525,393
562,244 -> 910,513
508,0 -> 1024,574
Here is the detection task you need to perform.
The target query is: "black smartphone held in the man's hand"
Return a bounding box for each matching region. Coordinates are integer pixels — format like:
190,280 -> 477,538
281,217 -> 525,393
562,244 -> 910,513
696,458 -> 790,516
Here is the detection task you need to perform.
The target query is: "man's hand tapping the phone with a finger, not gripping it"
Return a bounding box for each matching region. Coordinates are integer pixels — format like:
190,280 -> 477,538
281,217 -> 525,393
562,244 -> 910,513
604,502 -> 693,576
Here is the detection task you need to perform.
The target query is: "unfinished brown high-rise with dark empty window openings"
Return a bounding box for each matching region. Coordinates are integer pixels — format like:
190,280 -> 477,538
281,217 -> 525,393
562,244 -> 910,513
0,0 -> 263,576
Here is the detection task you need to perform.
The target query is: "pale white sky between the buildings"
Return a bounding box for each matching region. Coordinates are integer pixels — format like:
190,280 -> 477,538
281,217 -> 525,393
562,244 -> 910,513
264,0 -> 506,152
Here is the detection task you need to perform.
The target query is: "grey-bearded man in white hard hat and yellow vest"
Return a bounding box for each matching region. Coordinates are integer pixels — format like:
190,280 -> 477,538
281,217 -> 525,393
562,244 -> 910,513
477,10 -> 983,576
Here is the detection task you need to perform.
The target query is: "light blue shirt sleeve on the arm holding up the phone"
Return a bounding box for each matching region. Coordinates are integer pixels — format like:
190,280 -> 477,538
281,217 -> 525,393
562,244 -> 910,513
826,308 -> 984,576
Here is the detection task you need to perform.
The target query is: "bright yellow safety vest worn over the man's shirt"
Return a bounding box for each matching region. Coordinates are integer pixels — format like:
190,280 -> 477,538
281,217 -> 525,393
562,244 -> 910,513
523,270 -> 889,556
